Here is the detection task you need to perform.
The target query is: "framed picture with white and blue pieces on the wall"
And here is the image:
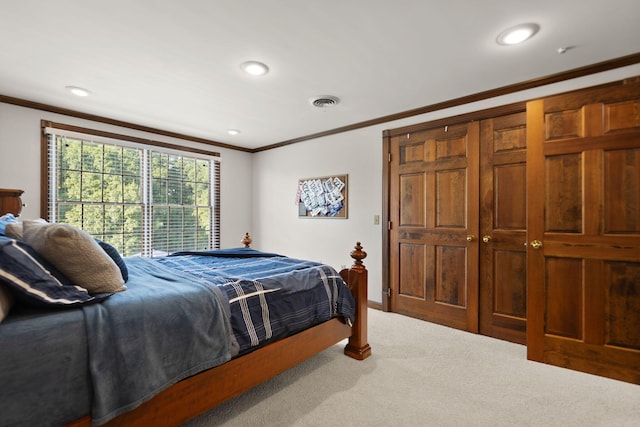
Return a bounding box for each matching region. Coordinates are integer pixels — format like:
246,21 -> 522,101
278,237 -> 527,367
296,174 -> 348,218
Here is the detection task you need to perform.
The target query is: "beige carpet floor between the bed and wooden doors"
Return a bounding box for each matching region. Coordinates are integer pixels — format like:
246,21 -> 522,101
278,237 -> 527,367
184,310 -> 640,427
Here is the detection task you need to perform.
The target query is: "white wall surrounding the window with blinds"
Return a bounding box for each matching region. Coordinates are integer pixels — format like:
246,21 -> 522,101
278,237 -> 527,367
0,103 -> 253,247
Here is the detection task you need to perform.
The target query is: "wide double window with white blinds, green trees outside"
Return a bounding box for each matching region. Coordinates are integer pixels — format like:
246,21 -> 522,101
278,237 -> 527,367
45,123 -> 220,256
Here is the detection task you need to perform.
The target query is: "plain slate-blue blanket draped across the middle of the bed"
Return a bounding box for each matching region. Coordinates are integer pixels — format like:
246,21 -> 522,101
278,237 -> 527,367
83,258 -> 231,425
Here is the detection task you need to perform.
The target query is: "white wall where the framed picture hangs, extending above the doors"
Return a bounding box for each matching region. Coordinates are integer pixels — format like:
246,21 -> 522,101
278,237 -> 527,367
251,64 -> 640,302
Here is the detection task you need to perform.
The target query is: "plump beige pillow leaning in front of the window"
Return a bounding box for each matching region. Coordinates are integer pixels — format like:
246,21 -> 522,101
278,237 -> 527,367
22,220 -> 126,294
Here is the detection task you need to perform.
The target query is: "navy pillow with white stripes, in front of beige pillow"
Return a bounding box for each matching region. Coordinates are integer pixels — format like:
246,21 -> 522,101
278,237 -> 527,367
0,237 -> 109,307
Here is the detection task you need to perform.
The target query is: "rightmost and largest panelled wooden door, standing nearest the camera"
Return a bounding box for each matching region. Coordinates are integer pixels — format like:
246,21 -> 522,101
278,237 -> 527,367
527,79 -> 640,384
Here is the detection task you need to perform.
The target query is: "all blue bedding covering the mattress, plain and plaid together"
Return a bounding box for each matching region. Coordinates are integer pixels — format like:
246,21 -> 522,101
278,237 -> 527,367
0,249 -> 354,426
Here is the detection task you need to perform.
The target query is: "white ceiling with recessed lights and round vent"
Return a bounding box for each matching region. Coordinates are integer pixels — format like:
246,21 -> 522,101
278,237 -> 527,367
0,0 -> 640,149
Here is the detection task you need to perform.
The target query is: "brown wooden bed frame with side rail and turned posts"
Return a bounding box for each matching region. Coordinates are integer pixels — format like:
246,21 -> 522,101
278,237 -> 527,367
0,189 -> 371,427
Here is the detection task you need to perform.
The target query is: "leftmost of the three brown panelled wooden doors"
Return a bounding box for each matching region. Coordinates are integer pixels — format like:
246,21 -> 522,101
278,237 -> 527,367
389,122 -> 479,332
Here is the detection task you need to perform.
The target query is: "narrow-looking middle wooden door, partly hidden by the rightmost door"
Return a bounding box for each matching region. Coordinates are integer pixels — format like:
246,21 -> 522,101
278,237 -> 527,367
479,112 -> 527,344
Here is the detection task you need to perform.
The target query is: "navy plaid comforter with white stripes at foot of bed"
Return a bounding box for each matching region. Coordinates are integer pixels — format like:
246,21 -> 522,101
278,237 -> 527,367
158,248 -> 355,353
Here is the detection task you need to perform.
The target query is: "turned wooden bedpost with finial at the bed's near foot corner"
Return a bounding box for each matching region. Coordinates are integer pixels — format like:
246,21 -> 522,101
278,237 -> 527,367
340,242 -> 371,360
